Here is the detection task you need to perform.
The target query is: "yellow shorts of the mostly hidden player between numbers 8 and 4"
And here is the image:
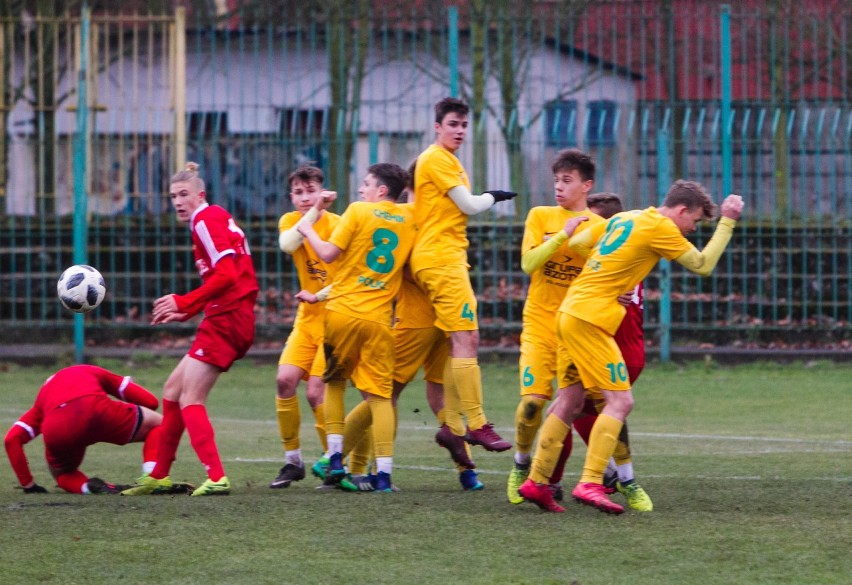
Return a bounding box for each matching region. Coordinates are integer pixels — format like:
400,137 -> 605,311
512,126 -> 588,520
393,327 -> 450,384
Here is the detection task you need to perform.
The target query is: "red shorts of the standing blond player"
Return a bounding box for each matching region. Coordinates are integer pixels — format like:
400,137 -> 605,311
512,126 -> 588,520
187,300 -> 254,372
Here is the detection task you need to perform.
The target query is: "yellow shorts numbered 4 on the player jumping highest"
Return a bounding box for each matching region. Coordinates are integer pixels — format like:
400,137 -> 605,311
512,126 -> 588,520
414,265 -> 479,331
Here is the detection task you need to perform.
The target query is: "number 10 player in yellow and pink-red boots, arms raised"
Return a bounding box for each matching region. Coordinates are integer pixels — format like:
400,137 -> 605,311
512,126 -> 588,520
519,181 -> 743,514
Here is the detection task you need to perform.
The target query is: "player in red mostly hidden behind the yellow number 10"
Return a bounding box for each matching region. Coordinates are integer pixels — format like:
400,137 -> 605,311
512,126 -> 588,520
550,193 -> 653,512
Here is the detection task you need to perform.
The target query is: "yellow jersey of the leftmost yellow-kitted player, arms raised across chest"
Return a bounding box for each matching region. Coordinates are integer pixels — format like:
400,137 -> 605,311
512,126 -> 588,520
278,211 -> 340,328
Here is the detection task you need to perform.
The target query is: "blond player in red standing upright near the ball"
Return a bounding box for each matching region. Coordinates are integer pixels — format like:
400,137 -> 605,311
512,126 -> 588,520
122,163 -> 258,496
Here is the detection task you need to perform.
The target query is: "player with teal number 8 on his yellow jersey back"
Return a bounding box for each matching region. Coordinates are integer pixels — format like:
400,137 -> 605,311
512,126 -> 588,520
299,163 -> 417,492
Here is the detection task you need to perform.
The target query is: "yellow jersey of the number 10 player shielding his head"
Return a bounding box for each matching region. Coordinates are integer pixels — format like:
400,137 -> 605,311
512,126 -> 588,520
559,207 -> 694,335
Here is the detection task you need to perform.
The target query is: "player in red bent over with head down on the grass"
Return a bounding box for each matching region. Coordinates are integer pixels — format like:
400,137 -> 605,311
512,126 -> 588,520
5,365 -> 163,494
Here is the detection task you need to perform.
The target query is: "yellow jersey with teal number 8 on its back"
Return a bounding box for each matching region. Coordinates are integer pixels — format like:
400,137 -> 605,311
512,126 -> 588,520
326,201 -> 417,326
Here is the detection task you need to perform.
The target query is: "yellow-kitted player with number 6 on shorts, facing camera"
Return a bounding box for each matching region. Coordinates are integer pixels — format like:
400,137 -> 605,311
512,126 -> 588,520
506,149 -> 604,504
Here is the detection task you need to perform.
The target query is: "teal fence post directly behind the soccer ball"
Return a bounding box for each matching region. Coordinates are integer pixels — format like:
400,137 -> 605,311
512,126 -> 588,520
73,2 -> 92,364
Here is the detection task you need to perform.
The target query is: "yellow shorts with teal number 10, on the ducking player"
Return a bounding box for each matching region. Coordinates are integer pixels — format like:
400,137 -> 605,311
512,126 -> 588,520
557,313 -> 630,399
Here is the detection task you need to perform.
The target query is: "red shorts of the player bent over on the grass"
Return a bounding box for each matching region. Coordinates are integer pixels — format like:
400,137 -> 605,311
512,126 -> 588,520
41,394 -> 142,472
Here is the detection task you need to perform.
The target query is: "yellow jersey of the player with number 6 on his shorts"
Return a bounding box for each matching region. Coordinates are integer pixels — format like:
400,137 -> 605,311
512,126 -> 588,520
521,205 -> 605,331
